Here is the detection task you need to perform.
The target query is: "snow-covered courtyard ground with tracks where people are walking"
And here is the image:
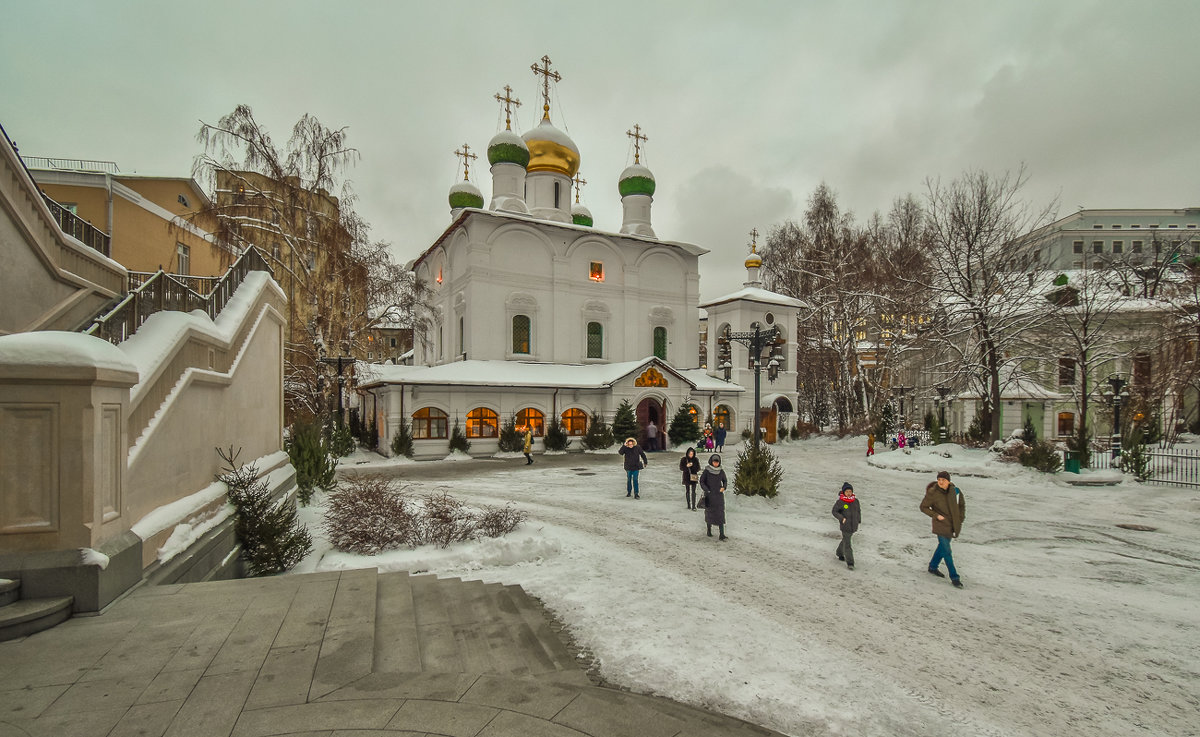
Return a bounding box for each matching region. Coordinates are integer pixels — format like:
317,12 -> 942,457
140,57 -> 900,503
298,438 -> 1200,737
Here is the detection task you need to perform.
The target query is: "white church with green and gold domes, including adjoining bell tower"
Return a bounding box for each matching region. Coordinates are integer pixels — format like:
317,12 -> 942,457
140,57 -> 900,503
359,56 -> 803,459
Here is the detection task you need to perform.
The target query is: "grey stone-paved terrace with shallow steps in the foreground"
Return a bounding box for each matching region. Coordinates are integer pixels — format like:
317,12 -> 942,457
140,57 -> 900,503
0,569 -> 776,737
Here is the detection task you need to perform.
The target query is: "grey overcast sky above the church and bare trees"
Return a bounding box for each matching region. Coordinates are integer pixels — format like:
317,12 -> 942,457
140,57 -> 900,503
0,0 -> 1200,299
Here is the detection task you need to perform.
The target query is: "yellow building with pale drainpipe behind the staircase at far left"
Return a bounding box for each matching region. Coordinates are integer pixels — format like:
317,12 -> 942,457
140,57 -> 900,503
25,157 -> 238,276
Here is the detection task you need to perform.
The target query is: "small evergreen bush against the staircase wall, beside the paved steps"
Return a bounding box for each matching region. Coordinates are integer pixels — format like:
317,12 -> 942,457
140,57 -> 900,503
217,448 -> 312,576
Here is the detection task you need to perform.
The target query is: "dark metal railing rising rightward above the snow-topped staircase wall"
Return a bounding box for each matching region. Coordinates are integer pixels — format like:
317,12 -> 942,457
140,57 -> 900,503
84,246 -> 274,344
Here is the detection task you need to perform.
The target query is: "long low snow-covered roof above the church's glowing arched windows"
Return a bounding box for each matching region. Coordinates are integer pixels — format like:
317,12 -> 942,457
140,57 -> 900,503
359,356 -> 743,391
